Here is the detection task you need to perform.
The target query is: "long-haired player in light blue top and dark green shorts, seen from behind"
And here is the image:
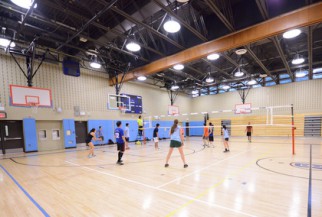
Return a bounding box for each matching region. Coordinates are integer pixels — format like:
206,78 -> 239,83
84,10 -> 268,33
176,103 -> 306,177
164,119 -> 188,168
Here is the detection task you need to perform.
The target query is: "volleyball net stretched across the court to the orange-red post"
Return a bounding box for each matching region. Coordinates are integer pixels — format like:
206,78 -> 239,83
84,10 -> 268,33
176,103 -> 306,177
145,105 -> 296,154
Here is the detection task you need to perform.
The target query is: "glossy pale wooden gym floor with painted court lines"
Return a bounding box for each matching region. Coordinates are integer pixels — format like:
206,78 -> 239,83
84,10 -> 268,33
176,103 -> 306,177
0,137 -> 322,217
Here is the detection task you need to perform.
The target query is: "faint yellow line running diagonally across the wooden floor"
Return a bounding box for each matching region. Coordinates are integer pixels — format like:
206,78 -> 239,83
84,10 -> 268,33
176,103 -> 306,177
166,151 -> 272,217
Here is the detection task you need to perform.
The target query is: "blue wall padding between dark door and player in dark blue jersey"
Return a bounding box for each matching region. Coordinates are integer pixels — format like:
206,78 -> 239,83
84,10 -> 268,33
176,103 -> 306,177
87,120 -> 115,145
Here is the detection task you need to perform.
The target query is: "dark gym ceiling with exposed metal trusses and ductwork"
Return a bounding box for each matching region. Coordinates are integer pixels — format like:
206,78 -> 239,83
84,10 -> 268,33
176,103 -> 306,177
0,0 -> 322,95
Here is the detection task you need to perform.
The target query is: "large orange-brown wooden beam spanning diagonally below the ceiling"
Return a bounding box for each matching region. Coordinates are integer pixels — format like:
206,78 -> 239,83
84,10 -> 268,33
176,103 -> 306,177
110,2 -> 322,85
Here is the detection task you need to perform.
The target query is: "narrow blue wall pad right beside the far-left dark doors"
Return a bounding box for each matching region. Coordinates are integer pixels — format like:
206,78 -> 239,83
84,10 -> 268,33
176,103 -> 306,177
23,118 -> 38,152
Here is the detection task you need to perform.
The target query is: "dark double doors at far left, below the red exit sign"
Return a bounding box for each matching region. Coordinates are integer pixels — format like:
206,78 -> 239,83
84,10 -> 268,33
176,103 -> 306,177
0,121 -> 24,154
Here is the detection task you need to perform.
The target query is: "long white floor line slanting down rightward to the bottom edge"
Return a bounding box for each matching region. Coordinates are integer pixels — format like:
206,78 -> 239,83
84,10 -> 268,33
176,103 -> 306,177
65,161 -> 255,217
